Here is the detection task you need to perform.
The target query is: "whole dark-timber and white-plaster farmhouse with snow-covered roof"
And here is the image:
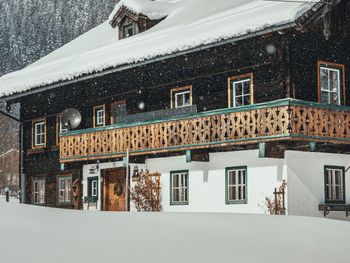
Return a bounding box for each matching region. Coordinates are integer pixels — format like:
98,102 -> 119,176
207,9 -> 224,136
0,0 -> 350,219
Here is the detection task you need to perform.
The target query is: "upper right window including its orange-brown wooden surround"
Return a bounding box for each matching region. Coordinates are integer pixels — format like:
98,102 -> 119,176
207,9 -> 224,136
318,61 -> 345,105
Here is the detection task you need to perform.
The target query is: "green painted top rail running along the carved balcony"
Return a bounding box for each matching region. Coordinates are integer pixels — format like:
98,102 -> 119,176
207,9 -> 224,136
60,98 -> 350,137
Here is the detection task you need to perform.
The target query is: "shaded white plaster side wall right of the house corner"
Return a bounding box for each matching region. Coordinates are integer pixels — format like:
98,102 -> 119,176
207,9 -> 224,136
285,151 -> 350,220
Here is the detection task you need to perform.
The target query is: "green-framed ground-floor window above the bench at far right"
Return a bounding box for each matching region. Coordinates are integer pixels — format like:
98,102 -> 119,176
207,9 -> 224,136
324,166 -> 345,204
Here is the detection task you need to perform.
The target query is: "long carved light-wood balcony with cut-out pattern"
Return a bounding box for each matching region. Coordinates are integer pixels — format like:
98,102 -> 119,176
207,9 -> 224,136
60,99 -> 350,162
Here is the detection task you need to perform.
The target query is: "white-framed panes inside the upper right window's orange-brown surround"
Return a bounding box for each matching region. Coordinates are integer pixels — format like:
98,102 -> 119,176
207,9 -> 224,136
319,64 -> 342,105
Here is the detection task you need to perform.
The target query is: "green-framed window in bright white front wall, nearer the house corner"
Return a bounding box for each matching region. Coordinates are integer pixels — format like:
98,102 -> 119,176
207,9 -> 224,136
226,166 -> 247,204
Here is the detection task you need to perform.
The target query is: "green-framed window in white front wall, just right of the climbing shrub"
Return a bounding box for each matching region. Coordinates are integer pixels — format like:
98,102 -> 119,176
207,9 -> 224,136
170,170 -> 188,205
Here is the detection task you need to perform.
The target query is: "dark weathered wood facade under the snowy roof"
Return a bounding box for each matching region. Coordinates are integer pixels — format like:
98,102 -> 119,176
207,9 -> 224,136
5,1 -> 350,207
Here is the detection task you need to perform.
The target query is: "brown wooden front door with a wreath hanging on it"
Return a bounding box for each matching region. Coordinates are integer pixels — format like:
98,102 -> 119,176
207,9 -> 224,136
103,168 -> 127,211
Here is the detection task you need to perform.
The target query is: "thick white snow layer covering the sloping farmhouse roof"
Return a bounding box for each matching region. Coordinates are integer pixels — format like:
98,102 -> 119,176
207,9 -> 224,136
0,0 -> 320,97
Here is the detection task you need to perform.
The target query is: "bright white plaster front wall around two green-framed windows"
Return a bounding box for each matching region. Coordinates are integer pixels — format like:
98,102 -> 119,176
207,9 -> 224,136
146,150 -> 287,213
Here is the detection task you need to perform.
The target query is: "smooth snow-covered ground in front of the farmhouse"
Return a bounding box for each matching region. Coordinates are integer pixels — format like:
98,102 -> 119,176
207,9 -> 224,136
0,202 -> 350,263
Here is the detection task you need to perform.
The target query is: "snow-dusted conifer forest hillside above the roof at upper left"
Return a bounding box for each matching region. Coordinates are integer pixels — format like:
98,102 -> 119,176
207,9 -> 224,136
0,0 -> 118,76
